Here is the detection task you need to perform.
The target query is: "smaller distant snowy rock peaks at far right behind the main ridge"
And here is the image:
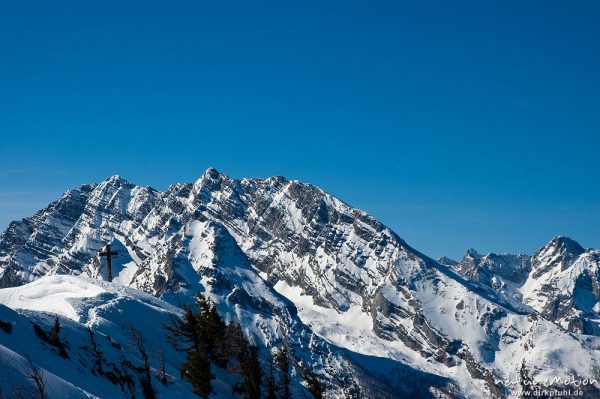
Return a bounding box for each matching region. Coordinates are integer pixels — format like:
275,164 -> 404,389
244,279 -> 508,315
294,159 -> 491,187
455,236 -> 600,335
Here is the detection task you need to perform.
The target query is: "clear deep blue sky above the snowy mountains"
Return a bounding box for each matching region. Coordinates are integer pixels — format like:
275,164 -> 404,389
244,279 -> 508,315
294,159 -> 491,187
0,0 -> 600,257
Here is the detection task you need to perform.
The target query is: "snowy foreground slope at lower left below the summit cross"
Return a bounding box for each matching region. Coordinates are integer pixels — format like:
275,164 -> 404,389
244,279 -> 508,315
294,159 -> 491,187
0,276 -> 194,398
